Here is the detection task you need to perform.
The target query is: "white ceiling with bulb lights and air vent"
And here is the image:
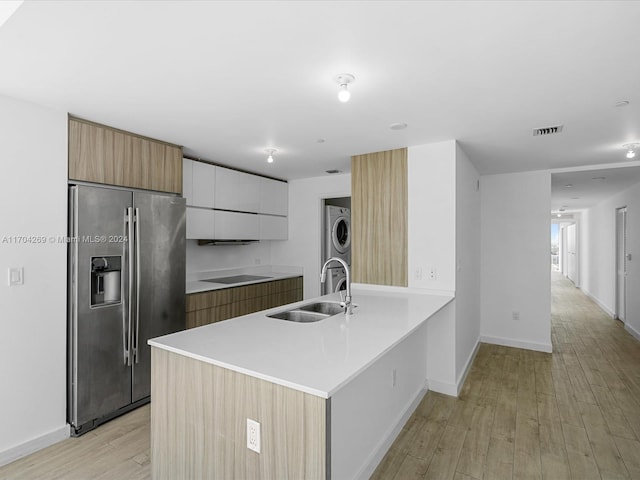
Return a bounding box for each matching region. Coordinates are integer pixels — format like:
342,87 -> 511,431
0,1 -> 640,198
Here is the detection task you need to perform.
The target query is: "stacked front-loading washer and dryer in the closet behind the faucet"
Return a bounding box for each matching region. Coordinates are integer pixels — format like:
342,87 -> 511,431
322,205 -> 351,295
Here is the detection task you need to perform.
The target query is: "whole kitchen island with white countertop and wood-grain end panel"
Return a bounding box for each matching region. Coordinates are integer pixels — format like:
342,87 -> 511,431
149,286 -> 453,479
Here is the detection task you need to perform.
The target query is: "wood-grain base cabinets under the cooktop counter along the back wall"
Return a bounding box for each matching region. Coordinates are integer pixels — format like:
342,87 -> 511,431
186,277 -> 303,328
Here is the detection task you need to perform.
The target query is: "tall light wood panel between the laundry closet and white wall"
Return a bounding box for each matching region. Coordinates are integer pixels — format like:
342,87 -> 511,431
351,148 -> 408,287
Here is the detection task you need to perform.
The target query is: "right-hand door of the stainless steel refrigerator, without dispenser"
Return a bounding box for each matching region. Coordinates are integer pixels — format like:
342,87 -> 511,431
133,192 -> 186,402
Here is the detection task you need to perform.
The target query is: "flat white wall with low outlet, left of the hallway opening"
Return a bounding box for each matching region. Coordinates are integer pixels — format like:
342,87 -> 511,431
480,171 -> 551,352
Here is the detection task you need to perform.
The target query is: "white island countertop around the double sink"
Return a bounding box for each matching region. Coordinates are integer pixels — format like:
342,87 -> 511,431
148,284 -> 453,398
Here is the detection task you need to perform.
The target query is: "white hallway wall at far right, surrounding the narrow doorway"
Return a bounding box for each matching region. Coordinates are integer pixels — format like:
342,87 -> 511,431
580,184 -> 640,338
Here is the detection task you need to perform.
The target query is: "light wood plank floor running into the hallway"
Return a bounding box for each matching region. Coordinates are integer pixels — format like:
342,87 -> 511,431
0,274 -> 640,480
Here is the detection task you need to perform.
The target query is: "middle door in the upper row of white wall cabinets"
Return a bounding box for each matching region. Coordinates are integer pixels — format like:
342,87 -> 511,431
215,167 -> 261,212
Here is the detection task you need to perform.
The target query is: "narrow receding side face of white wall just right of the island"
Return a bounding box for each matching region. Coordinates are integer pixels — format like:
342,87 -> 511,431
455,145 -> 480,385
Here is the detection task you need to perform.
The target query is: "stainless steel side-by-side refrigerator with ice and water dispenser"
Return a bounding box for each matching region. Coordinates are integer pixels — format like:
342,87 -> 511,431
67,185 -> 186,435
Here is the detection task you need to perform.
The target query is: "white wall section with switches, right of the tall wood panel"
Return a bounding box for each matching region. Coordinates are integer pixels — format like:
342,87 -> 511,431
407,140 -> 456,293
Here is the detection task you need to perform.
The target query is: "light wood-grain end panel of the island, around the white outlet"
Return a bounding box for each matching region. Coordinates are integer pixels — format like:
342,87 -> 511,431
151,347 -> 327,480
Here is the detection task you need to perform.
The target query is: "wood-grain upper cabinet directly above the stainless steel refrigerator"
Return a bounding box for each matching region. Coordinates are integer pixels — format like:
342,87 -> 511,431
69,117 -> 182,193
